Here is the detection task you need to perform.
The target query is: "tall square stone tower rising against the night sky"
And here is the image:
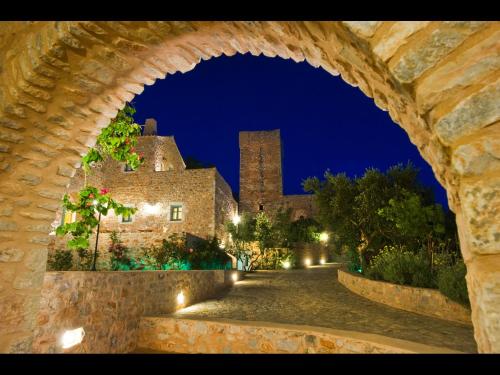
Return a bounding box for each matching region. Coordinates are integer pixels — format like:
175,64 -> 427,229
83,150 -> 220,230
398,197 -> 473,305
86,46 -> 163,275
239,129 -> 283,213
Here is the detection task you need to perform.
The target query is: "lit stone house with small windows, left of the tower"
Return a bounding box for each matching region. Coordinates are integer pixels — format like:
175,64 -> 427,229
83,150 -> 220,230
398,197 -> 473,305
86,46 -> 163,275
51,119 -> 238,254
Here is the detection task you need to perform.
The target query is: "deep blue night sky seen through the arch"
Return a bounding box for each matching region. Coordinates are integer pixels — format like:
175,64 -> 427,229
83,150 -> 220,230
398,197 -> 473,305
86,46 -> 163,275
133,54 -> 447,207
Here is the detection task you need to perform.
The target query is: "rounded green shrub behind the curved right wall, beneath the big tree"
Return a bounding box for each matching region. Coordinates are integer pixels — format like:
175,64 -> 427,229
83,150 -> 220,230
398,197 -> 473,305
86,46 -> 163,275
366,246 -> 436,288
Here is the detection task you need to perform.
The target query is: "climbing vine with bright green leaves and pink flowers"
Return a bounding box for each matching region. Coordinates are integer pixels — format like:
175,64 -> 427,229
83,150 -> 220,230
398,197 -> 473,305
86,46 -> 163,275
56,104 -> 144,262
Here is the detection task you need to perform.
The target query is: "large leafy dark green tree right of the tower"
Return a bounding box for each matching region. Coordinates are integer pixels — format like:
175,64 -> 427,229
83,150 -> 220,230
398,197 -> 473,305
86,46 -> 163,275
303,163 -> 456,268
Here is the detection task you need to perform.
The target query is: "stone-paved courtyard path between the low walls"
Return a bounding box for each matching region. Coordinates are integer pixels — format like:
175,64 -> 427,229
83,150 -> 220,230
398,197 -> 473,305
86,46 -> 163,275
173,265 -> 477,353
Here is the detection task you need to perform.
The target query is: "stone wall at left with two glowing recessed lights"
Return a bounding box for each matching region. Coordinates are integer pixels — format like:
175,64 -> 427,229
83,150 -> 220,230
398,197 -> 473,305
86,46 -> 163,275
33,270 -> 235,353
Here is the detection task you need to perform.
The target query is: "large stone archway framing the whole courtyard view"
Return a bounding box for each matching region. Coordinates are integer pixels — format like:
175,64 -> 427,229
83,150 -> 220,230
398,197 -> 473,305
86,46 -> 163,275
0,21 -> 500,352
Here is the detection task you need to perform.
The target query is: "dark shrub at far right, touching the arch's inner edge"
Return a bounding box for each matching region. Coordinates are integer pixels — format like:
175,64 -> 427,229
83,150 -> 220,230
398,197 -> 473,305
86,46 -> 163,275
437,261 -> 470,307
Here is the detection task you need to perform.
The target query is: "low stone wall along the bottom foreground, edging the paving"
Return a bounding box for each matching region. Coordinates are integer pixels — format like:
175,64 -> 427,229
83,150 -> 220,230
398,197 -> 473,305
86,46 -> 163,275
136,317 -> 458,354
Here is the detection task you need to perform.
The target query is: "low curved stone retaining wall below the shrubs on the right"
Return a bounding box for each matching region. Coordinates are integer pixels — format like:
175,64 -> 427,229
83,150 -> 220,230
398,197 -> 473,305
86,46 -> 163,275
338,270 -> 472,324
